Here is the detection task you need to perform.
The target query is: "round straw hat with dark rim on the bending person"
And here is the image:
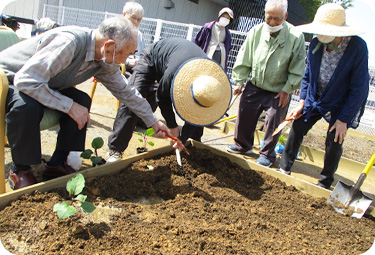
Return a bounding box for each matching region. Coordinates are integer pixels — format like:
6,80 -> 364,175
171,58 -> 232,126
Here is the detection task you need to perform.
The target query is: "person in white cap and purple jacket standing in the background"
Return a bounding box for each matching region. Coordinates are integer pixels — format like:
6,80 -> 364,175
194,7 -> 234,71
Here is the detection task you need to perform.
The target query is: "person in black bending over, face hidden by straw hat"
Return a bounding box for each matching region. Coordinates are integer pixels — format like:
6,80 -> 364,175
106,37 -> 232,162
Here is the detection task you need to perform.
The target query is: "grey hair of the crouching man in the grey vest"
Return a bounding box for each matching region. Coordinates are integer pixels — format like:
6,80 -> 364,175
98,16 -> 137,50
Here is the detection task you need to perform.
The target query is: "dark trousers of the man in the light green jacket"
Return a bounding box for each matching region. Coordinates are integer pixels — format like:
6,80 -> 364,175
234,82 -> 289,162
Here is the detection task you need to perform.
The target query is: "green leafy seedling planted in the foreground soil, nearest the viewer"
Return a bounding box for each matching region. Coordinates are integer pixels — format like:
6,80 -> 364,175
53,174 -> 96,220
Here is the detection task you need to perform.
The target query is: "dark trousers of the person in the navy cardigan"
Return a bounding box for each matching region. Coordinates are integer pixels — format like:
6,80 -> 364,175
280,111 -> 343,188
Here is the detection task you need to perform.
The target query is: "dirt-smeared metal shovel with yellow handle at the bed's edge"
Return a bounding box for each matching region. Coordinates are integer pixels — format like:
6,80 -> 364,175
327,152 -> 375,219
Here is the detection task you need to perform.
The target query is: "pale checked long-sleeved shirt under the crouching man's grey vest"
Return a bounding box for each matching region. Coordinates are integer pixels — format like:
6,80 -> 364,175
14,31 -> 157,126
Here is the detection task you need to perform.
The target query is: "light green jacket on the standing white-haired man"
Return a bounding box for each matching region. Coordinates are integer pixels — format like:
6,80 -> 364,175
232,22 -> 306,94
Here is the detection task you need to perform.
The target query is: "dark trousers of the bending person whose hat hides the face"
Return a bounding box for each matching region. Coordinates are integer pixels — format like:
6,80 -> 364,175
108,68 -> 203,152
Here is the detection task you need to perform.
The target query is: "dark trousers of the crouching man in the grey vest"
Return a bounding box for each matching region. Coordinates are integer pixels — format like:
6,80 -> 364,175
6,85 -> 91,165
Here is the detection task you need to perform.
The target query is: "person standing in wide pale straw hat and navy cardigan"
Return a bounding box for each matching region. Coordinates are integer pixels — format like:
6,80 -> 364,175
278,3 -> 369,189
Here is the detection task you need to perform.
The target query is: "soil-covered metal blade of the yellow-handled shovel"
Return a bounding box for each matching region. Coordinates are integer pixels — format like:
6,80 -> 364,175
327,182 -> 372,219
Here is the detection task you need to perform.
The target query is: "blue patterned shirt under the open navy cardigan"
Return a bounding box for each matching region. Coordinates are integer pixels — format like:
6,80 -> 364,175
317,36 -> 351,96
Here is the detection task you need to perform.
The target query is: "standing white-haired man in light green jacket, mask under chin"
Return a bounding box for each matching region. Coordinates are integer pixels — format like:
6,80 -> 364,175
227,0 -> 306,166
